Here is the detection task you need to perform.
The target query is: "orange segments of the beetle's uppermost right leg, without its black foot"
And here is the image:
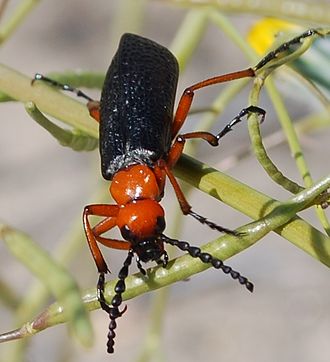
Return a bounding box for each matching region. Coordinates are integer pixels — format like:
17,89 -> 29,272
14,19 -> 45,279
172,68 -> 255,138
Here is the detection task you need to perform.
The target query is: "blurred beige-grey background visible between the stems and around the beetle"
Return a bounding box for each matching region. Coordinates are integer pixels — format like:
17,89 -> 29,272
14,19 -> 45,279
0,0 -> 330,362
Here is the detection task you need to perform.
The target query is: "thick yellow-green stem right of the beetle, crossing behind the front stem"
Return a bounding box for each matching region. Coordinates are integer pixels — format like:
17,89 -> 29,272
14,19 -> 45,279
175,156 -> 330,266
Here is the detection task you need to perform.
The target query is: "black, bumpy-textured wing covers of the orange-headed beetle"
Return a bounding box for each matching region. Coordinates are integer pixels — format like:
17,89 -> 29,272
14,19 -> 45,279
100,34 -> 178,179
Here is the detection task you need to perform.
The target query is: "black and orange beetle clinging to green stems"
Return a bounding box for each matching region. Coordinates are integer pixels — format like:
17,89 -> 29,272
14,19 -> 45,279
34,33 -> 265,353
